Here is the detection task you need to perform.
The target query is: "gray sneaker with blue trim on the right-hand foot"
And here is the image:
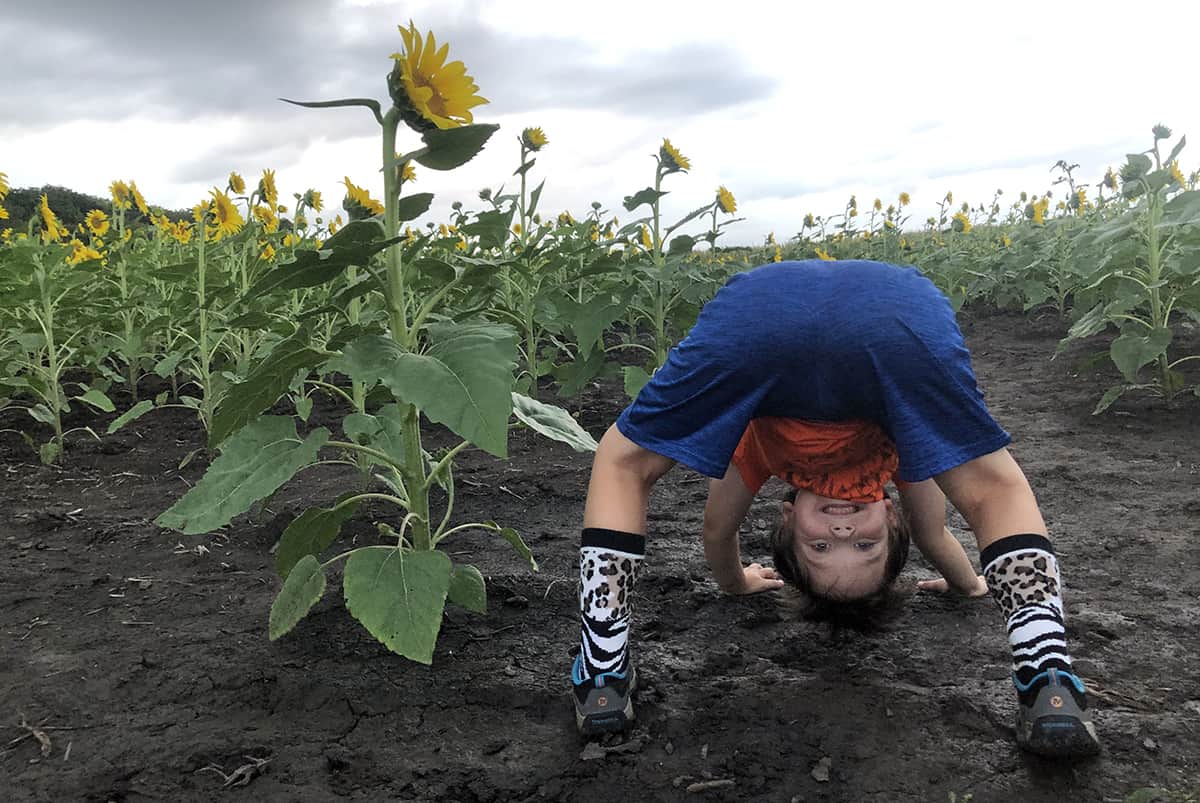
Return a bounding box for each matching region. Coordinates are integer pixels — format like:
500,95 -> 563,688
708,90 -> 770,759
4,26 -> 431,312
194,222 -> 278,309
1016,669 -> 1100,757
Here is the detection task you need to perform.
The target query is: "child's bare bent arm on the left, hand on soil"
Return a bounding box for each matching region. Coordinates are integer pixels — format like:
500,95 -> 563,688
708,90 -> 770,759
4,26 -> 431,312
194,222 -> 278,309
704,465 -> 784,594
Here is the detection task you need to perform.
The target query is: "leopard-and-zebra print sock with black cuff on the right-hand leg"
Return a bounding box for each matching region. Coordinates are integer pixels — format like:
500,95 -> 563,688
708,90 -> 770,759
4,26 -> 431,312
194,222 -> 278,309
979,534 -> 1086,706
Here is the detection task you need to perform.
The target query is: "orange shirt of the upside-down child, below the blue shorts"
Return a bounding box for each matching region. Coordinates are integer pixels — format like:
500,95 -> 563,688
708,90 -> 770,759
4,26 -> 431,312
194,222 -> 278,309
733,418 -> 899,504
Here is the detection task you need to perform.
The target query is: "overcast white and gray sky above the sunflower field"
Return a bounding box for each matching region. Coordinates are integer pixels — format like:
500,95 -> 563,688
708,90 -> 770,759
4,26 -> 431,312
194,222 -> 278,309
0,0 -> 1200,245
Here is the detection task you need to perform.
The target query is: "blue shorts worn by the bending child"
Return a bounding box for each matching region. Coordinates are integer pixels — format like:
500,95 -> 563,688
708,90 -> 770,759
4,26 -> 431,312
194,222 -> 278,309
617,260 -> 1010,483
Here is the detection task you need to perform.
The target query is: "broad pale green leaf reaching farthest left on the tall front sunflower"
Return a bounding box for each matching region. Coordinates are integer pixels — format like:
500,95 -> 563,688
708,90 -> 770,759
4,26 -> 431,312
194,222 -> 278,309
155,415 -> 329,535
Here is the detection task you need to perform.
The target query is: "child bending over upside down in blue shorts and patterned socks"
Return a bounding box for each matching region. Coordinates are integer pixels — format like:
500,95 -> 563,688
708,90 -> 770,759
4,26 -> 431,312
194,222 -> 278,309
571,260 -> 1099,756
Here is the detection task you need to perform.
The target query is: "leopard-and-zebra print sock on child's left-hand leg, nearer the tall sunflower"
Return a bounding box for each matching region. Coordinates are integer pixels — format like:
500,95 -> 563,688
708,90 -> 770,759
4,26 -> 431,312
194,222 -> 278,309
576,527 -> 646,681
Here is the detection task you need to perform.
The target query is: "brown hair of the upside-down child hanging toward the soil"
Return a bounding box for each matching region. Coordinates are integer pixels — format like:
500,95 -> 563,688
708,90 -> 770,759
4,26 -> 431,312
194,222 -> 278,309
770,489 -> 910,634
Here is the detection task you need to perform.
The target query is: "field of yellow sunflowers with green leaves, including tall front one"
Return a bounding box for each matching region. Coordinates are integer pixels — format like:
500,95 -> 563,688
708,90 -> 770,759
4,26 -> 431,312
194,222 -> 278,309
0,23 -> 1200,799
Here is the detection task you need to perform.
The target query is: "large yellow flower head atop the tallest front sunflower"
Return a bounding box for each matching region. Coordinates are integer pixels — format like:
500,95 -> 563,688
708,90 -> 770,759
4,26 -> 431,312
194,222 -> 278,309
388,20 -> 487,131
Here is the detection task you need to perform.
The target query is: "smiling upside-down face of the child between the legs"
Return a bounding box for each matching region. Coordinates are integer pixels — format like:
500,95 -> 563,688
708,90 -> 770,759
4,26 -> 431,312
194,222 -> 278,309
784,491 -> 894,599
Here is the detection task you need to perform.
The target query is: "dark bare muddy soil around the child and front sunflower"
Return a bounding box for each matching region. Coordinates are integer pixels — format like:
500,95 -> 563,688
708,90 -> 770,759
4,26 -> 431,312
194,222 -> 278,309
0,311 -> 1200,803
